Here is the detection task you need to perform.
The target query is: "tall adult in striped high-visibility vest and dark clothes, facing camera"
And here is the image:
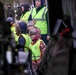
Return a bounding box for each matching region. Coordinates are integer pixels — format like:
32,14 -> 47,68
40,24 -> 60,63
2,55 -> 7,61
29,0 -> 49,44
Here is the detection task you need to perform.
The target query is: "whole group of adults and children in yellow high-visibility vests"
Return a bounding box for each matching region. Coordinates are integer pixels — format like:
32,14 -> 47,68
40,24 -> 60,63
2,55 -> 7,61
7,0 -> 50,73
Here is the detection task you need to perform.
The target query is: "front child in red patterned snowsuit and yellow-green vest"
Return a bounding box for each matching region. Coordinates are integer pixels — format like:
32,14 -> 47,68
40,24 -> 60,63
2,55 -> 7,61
29,28 -> 46,69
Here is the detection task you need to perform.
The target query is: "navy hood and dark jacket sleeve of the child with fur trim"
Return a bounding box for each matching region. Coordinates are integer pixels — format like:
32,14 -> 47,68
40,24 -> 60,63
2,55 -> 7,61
18,22 -> 27,51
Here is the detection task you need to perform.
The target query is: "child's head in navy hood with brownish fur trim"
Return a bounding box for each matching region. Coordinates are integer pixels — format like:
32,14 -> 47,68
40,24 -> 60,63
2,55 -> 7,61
16,22 -> 27,35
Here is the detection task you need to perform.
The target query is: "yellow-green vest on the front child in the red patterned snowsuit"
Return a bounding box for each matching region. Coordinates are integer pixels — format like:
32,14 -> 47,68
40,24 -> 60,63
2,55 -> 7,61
29,40 -> 42,60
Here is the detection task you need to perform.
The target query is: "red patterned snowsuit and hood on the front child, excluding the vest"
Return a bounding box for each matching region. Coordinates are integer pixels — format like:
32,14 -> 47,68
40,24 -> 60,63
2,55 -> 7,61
30,27 -> 46,69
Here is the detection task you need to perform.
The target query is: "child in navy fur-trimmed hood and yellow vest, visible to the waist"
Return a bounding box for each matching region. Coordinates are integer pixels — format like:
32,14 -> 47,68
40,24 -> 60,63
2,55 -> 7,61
16,22 -> 31,52
